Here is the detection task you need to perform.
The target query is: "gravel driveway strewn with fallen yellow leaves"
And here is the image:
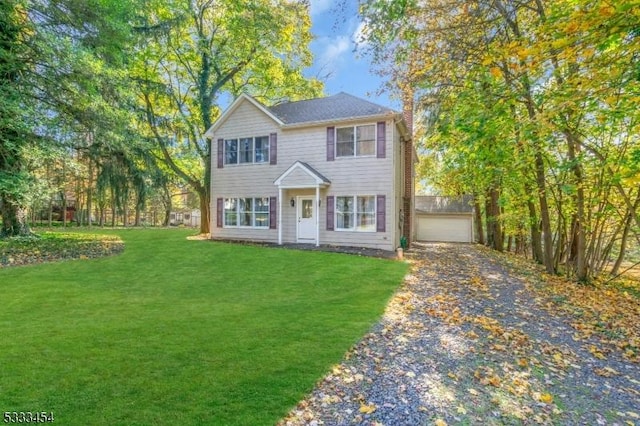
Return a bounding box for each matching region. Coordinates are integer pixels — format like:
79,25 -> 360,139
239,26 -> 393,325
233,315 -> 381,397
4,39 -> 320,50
281,244 -> 640,425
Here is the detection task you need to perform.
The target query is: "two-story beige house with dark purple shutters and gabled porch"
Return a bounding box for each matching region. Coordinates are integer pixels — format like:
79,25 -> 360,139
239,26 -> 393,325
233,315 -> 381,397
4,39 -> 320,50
206,93 -> 414,250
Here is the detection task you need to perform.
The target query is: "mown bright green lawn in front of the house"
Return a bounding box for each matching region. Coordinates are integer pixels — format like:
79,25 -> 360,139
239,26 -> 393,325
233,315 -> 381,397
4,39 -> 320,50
0,230 -> 407,425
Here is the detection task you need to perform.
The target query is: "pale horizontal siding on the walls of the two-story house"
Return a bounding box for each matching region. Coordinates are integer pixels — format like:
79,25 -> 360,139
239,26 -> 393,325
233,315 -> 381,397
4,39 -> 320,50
211,97 -> 402,250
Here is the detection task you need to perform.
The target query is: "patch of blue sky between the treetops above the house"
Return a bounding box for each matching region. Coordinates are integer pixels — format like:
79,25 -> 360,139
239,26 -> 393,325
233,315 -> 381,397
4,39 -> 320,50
306,0 -> 399,110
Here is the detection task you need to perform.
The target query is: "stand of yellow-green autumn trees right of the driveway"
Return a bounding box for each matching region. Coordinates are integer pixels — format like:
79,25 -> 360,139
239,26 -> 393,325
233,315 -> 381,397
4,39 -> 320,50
361,0 -> 640,281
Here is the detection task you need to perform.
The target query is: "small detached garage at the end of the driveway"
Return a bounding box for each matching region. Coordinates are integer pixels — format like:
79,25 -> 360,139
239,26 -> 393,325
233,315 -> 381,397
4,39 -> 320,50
415,195 -> 474,243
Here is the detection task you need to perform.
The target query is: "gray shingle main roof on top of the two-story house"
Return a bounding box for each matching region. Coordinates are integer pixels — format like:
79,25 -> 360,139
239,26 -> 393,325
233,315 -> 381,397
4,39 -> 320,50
268,92 -> 396,124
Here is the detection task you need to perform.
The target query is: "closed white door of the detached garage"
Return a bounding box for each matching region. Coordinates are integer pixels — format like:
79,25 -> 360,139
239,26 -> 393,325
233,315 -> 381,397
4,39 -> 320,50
417,216 -> 473,243
